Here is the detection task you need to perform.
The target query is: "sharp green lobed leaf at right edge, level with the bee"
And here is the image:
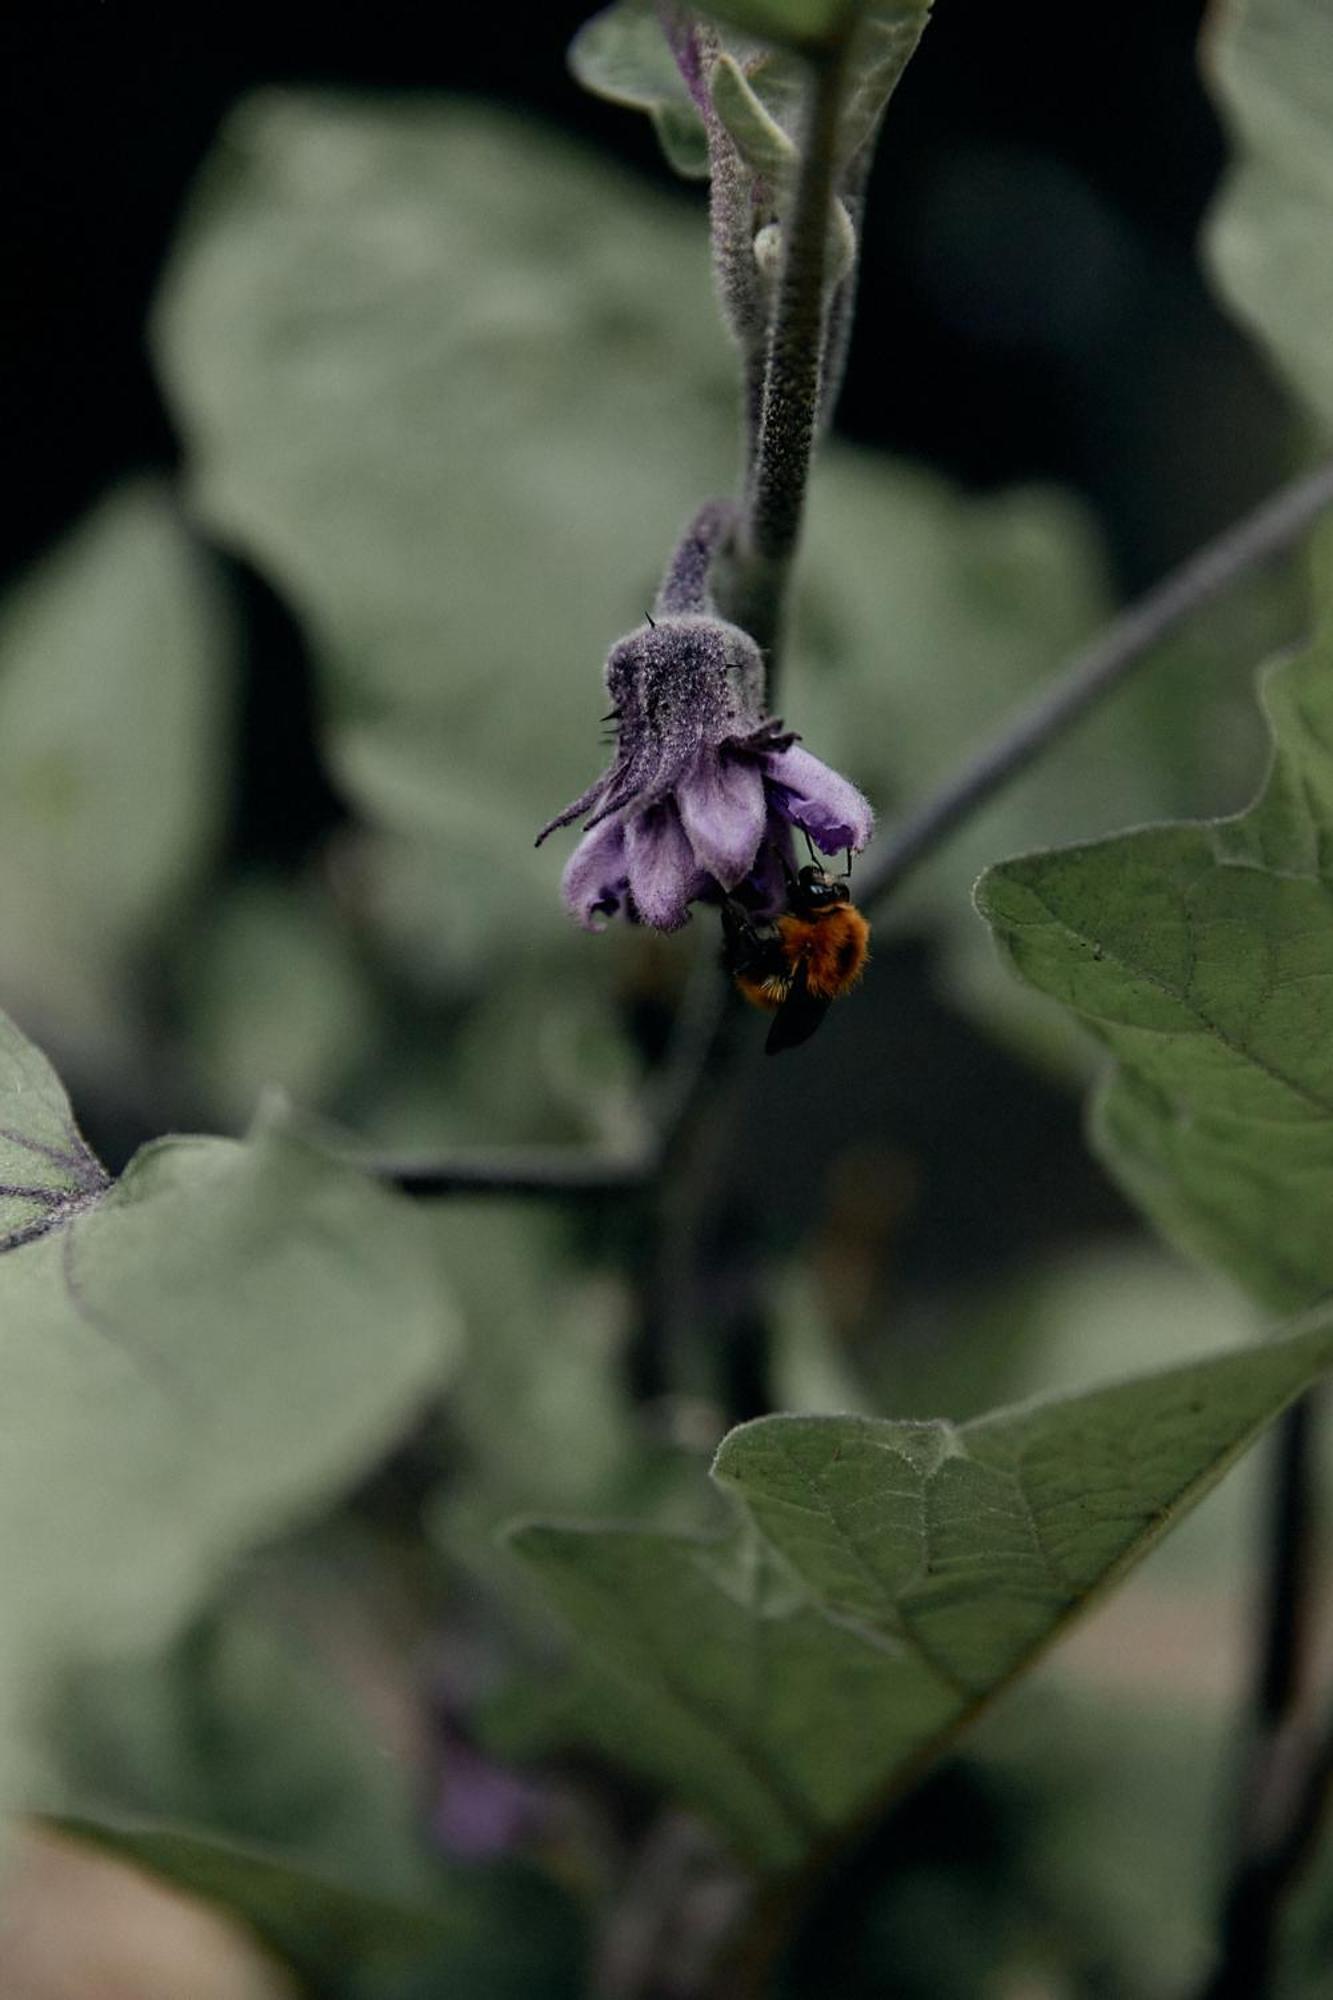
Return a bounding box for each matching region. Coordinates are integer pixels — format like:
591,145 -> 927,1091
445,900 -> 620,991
977,556 -> 1333,1310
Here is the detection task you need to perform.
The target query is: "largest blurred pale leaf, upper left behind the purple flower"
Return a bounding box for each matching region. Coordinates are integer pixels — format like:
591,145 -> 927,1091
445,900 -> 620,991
158,92 -> 735,972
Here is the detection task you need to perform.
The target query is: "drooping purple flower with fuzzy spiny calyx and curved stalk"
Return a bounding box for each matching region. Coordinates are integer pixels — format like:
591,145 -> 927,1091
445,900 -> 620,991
538,502 -> 873,930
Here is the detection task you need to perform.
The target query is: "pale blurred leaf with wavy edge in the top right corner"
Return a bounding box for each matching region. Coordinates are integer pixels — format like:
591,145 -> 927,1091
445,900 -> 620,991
1205,0 -> 1333,426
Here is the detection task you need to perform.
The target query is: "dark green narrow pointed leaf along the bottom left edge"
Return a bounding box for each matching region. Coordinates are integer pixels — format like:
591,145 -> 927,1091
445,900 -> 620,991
60,1818 -> 580,2000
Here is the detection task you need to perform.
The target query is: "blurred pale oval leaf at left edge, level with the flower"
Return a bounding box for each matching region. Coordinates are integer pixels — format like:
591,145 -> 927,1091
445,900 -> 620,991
0,484 -> 232,1044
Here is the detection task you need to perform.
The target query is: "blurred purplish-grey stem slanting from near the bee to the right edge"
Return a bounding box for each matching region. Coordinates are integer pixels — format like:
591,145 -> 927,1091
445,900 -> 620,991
857,462 -> 1333,906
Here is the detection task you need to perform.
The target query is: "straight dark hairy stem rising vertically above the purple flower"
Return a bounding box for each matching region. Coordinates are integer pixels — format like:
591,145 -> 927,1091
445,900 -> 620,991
729,48 -> 845,672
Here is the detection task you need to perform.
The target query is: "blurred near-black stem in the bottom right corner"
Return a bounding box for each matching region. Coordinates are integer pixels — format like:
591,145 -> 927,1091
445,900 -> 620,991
1199,1396 -> 1333,2000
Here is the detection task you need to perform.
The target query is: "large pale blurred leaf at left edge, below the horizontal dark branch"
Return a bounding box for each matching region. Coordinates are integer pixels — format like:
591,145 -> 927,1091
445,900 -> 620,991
0,1008 -> 452,1808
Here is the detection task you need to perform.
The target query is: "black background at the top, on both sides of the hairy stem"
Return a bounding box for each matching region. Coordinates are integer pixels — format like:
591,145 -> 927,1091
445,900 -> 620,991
0,0 -> 1281,588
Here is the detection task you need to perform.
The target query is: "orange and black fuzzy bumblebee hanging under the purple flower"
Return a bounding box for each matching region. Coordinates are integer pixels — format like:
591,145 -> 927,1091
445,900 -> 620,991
723,866 -> 871,1056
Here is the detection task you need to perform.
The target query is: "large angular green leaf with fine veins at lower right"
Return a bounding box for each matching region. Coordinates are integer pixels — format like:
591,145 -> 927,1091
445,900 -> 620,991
514,1316 -> 1333,1870
